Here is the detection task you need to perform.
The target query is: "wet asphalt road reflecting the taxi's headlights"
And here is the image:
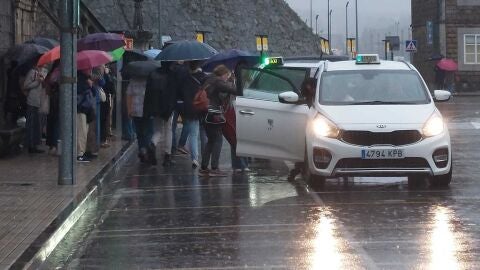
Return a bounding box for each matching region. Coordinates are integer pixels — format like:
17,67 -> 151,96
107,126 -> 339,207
44,97 -> 480,269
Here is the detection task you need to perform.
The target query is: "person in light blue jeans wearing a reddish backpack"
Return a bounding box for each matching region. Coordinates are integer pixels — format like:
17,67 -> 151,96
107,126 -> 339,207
177,61 -> 207,169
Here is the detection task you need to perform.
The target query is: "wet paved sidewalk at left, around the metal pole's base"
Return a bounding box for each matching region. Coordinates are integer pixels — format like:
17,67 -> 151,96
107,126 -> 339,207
0,137 -> 130,269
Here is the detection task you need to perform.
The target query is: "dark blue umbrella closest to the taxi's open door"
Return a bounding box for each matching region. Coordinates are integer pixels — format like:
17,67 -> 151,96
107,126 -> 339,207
202,49 -> 260,72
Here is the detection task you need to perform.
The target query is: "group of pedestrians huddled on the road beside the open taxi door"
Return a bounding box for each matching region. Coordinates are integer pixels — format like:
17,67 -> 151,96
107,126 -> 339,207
126,61 -> 249,176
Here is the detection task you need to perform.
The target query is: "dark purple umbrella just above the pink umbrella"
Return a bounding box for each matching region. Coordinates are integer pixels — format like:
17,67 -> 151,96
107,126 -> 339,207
77,33 -> 125,52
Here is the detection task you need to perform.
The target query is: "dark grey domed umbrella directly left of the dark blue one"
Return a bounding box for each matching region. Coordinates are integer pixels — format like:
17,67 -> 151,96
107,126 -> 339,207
155,40 -> 217,61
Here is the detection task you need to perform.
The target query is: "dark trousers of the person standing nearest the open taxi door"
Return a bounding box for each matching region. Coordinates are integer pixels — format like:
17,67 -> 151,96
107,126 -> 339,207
202,124 -> 223,170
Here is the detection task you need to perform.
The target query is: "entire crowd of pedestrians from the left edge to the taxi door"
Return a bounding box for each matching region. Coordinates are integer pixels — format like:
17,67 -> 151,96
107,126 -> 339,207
5,39 -> 249,176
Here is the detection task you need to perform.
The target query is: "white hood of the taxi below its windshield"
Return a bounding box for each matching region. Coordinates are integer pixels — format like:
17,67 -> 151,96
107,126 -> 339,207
319,104 -> 435,125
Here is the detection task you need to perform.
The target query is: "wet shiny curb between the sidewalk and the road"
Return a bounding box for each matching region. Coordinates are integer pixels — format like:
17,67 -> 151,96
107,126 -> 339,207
9,142 -> 134,270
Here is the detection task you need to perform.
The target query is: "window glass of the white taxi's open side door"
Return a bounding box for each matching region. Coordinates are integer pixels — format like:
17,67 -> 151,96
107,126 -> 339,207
242,68 -> 307,102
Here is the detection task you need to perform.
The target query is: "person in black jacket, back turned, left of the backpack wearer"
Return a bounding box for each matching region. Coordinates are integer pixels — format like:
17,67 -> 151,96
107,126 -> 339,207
143,62 -> 176,167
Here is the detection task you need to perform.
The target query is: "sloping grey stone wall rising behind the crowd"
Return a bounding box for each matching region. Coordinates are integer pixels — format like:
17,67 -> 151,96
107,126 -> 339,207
83,0 -> 320,56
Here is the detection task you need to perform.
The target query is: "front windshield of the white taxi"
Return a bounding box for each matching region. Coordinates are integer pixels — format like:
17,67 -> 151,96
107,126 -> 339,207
319,70 -> 430,105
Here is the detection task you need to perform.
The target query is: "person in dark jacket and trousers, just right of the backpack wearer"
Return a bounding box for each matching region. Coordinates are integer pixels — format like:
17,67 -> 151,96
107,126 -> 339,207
200,65 -> 236,176
